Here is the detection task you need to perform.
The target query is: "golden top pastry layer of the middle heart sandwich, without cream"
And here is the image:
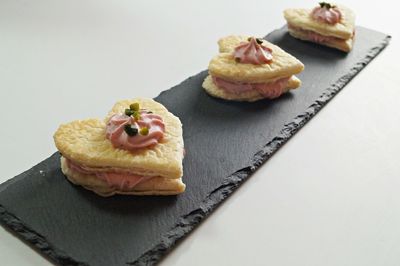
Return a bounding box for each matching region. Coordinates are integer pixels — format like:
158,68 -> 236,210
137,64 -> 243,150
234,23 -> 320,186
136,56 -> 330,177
208,36 -> 304,83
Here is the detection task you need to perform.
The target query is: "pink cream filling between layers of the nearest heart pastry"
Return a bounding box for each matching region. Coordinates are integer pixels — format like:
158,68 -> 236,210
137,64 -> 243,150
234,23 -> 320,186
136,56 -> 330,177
66,159 -> 154,191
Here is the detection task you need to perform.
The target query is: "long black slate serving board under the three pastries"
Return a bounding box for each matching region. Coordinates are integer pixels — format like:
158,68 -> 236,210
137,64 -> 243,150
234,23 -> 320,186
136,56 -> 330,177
0,27 -> 390,266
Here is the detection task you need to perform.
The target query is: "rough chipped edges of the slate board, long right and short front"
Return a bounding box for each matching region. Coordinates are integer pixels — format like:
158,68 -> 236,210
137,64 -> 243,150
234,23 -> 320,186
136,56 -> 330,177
0,30 -> 391,266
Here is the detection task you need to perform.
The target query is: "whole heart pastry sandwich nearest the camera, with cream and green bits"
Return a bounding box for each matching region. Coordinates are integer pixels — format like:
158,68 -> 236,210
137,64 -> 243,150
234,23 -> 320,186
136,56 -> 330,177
54,98 -> 185,196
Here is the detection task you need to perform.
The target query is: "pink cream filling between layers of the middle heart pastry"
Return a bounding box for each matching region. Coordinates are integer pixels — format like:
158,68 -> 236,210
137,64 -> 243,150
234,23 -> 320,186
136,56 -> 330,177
212,76 -> 290,99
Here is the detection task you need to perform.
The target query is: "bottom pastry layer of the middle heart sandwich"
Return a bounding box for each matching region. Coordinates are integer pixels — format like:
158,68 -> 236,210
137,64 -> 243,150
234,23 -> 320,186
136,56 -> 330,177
203,75 -> 301,102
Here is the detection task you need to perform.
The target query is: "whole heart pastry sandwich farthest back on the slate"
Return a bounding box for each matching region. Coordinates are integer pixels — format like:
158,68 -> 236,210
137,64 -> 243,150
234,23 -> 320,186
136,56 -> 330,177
283,2 -> 355,52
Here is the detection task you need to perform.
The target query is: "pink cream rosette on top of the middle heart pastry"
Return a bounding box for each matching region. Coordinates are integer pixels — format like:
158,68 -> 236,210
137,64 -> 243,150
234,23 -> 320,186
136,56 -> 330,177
233,37 -> 272,65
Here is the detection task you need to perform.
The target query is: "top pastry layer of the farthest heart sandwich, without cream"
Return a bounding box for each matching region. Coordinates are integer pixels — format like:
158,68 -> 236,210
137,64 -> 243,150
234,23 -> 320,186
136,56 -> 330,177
283,5 -> 355,39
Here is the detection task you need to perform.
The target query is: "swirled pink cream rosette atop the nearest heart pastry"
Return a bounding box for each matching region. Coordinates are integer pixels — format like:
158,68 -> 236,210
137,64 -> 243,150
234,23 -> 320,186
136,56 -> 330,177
106,111 -> 165,151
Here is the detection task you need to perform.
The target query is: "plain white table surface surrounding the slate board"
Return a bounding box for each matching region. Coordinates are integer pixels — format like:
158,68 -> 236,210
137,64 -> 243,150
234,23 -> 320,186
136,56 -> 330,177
0,0 -> 400,266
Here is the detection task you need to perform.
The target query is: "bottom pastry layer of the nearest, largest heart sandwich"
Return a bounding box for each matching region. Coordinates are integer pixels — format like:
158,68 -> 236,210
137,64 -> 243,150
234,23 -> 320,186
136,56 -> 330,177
61,157 -> 186,197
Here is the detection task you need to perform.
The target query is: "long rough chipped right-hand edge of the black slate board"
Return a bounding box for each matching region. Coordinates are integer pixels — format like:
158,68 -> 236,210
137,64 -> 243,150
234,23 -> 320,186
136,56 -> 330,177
131,32 -> 391,265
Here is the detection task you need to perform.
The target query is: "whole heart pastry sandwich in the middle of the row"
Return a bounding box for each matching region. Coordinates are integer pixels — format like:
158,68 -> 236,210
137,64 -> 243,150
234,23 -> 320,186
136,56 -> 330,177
203,35 -> 304,102
